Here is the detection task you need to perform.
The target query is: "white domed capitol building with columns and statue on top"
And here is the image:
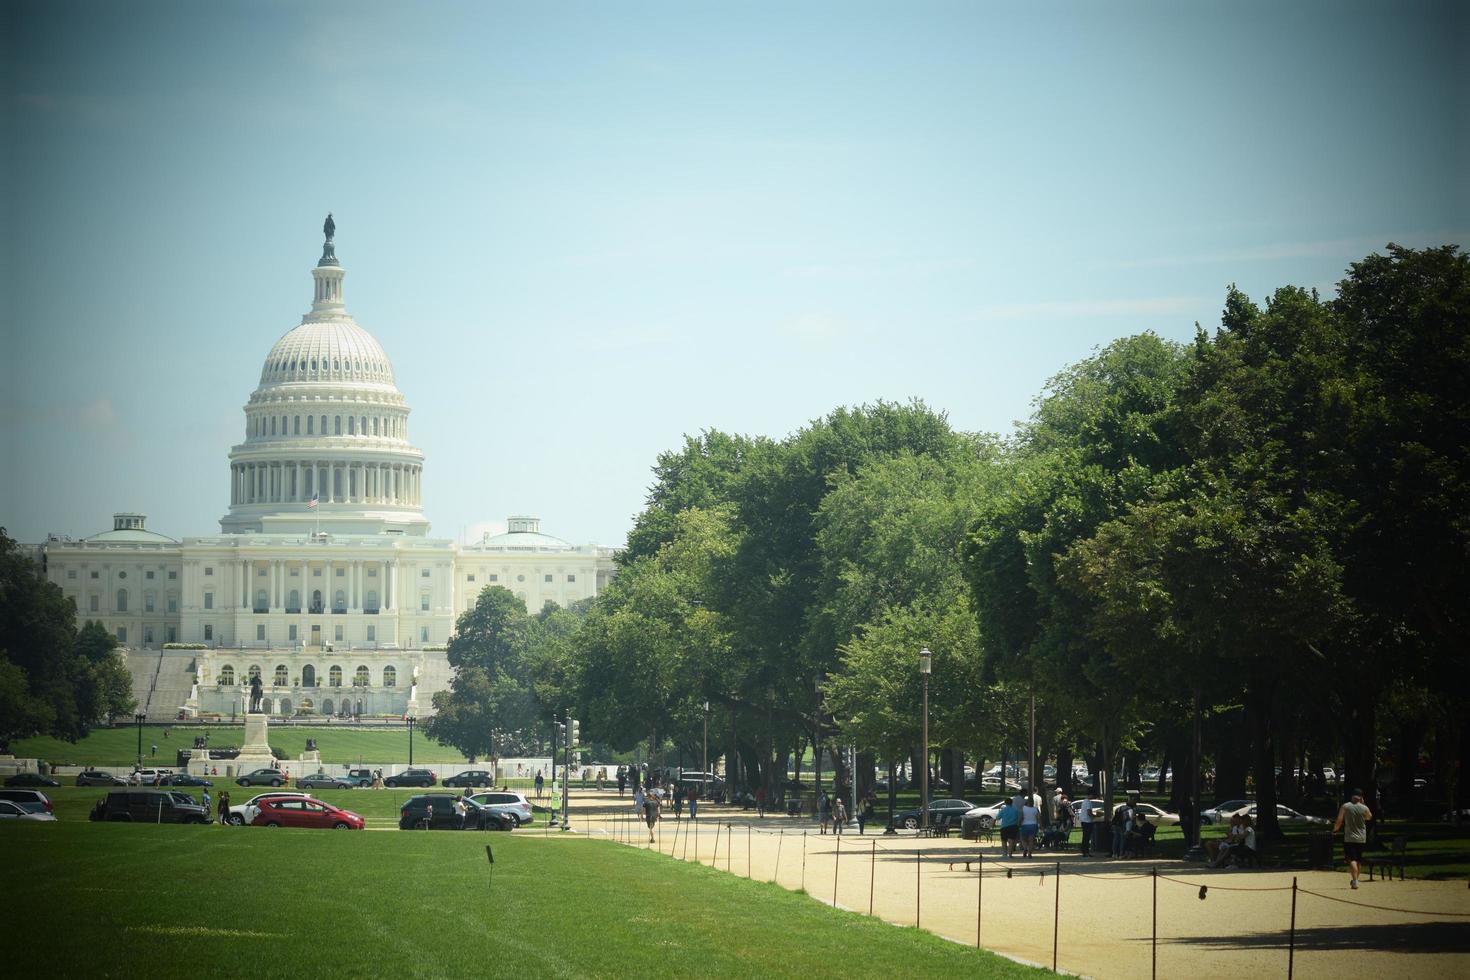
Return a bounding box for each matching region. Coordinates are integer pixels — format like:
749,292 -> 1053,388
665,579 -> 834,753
37,224 -> 614,720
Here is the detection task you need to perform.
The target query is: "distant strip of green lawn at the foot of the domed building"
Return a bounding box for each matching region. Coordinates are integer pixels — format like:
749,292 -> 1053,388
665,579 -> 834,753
10,724 -> 487,776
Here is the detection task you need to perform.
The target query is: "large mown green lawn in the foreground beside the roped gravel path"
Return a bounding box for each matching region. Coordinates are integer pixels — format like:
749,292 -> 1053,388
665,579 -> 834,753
0,823 -> 1039,980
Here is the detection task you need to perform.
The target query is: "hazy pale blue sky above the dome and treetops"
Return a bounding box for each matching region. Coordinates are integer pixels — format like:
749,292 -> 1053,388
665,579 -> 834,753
0,0 -> 1470,544
